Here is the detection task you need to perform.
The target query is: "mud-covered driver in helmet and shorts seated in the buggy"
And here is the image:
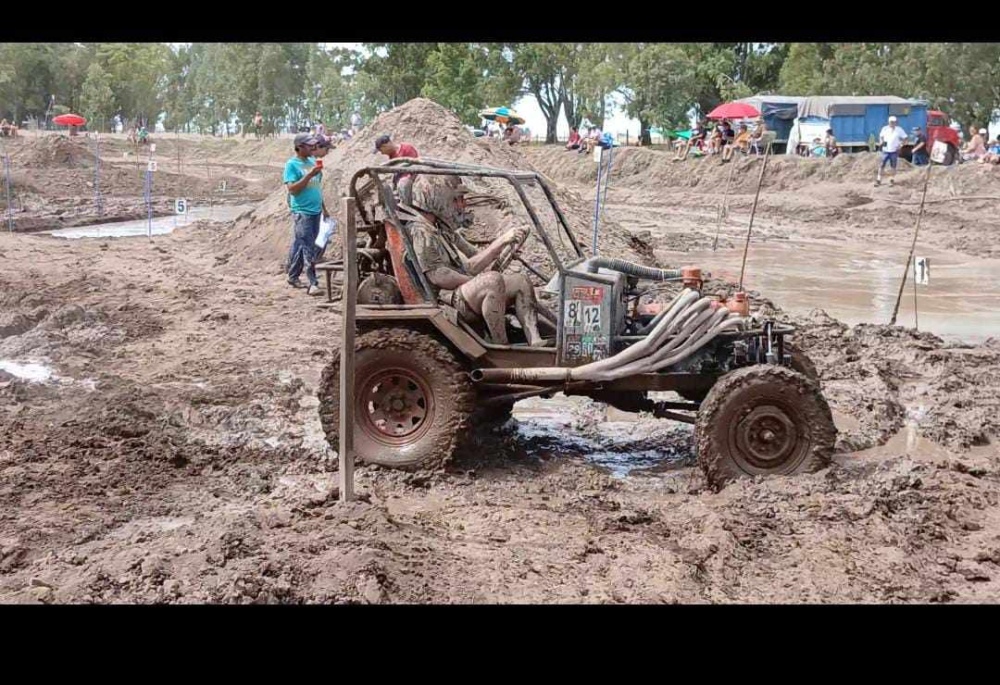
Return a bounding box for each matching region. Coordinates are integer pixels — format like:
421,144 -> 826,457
399,181 -> 544,347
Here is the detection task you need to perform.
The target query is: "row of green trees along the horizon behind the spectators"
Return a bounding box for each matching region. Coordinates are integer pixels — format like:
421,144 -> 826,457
0,43 -> 1000,142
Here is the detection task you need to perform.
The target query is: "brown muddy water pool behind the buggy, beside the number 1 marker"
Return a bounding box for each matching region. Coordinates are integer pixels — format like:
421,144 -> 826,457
657,240 -> 1000,343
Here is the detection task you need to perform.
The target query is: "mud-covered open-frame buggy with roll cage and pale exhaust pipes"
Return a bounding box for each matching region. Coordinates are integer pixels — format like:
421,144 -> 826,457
319,159 -> 836,487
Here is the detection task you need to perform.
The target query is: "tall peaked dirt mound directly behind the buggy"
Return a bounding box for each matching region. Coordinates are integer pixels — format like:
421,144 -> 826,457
227,98 -> 650,274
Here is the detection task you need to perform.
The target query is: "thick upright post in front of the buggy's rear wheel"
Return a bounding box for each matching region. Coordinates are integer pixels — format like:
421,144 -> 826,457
339,197 -> 358,502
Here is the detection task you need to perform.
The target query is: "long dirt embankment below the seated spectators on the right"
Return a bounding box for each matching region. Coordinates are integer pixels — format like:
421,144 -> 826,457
525,146 -> 1000,258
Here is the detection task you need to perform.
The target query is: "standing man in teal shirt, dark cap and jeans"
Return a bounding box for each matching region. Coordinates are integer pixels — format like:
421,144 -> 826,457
282,133 -> 323,295
